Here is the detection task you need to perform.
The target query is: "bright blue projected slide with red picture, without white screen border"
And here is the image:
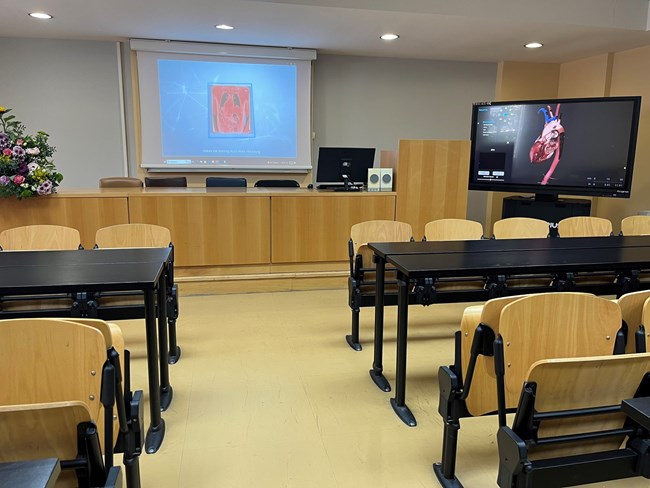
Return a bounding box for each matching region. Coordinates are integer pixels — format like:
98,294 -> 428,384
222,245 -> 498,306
157,59 -> 298,159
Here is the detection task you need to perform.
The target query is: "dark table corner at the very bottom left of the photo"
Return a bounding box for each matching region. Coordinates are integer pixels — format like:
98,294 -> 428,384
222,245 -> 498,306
0,458 -> 61,488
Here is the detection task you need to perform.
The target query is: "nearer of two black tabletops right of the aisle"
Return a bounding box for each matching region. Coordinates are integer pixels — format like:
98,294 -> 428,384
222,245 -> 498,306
387,242 -> 650,278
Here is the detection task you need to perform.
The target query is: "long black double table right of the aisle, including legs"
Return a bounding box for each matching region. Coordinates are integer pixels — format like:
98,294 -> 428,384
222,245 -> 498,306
369,237 -> 650,426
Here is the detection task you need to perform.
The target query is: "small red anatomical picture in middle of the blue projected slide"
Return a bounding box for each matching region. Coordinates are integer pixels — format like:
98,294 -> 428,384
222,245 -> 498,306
209,84 -> 254,137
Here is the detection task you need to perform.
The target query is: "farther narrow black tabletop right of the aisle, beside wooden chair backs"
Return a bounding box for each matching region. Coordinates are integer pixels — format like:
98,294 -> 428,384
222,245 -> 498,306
368,236 -> 650,259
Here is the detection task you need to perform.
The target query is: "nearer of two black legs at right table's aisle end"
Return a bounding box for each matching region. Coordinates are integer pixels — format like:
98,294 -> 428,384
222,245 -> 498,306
390,273 -> 417,427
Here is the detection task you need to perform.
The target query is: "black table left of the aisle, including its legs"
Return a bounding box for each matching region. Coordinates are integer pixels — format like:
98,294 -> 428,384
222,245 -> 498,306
0,248 -> 173,454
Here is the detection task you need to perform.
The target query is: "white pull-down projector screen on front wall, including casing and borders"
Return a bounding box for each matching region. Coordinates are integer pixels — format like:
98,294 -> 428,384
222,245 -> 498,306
131,40 -> 316,172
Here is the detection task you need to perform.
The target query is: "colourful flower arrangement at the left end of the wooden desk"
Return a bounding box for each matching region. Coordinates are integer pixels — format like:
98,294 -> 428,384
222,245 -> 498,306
0,107 -> 63,198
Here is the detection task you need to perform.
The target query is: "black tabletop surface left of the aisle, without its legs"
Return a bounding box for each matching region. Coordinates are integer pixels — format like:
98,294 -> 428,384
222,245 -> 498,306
0,248 -> 171,295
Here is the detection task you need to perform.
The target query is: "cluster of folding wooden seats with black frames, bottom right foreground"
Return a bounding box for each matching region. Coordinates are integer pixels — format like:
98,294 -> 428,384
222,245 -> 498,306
434,291 -> 650,488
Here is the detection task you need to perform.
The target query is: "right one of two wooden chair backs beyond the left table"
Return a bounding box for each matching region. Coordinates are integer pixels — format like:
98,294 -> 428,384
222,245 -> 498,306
95,224 -> 171,249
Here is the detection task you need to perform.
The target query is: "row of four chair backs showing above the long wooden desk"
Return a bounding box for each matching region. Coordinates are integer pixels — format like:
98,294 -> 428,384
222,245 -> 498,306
99,176 -> 300,188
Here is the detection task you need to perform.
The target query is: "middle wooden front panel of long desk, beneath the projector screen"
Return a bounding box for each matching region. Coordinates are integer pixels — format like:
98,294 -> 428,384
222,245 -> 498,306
129,193 -> 271,266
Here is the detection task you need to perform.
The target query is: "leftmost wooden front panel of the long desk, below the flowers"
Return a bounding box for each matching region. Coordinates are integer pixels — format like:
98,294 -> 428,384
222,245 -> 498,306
0,195 -> 129,249
